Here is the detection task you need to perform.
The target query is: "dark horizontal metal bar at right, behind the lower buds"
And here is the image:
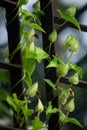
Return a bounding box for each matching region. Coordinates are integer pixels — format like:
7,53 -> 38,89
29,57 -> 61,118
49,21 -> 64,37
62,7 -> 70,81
60,77 -> 87,89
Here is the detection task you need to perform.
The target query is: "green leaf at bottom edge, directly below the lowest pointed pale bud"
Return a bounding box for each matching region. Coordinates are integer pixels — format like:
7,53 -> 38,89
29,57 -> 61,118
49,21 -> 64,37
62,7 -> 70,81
32,117 -> 43,130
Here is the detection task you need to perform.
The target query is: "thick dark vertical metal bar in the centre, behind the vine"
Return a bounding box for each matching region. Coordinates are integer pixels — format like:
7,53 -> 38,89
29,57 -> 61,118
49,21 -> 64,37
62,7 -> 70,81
40,0 -> 59,130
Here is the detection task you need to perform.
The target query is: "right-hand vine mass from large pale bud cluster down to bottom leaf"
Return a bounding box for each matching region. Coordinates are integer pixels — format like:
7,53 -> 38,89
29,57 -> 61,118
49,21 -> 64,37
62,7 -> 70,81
45,32 -> 83,128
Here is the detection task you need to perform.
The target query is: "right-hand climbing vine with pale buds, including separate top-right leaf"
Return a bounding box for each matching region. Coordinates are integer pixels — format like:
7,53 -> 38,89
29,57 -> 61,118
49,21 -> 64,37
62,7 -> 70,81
45,5 -> 84,128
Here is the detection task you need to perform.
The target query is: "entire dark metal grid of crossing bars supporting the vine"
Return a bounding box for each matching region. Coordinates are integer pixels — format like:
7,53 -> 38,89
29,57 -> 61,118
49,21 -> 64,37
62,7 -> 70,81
0,0 -> 87,130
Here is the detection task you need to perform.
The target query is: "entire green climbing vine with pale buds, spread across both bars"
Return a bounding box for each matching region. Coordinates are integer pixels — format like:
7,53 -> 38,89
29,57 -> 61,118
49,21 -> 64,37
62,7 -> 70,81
0,0 -> 83,130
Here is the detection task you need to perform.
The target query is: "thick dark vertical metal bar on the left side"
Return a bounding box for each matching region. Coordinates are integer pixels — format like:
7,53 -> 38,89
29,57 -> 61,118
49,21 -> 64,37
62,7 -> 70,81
5,0 -> 25,128
